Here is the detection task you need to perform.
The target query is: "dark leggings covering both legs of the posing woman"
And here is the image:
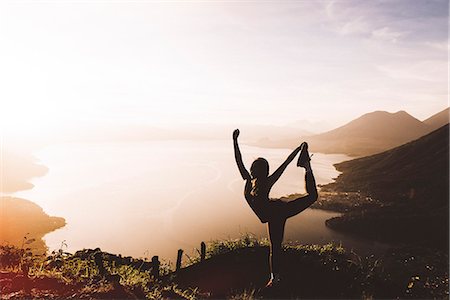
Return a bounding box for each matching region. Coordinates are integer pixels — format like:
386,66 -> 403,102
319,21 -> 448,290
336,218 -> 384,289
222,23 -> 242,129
267,170 -> 318,274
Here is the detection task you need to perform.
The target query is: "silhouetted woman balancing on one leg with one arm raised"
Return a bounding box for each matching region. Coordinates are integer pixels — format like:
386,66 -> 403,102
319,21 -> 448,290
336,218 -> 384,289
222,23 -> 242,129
233,129 -> 318,287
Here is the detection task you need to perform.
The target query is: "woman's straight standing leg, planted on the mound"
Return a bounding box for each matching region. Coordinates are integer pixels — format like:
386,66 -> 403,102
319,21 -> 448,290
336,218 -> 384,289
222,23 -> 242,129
268,218 -> 286,276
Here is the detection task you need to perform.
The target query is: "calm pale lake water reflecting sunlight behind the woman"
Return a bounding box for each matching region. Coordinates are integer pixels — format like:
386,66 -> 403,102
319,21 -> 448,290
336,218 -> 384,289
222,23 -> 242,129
15,141 -> 386,261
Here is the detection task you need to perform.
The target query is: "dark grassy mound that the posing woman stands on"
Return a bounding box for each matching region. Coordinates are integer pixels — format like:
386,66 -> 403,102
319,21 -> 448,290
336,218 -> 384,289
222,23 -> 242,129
176,235 -> 448,299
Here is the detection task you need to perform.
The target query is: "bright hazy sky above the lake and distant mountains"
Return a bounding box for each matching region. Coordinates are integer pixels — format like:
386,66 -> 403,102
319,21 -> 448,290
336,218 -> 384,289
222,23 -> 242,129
0,0 -> 449,137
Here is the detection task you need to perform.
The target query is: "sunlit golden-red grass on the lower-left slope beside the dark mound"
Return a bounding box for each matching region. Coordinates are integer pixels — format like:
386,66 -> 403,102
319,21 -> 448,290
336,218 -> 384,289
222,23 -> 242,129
0,241 -> 196,299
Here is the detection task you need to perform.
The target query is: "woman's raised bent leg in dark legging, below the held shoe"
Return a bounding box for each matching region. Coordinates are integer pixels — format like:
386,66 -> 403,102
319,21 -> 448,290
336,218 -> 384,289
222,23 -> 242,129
284,163 -> 318,219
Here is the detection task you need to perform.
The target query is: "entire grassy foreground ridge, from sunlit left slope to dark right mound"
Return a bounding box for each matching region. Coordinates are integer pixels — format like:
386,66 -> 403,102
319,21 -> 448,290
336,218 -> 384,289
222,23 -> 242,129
0,234 -> 448,299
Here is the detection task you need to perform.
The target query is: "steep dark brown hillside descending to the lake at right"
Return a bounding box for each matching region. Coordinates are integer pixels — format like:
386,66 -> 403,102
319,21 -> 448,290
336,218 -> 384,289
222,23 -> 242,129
322,124 -> 449,250
